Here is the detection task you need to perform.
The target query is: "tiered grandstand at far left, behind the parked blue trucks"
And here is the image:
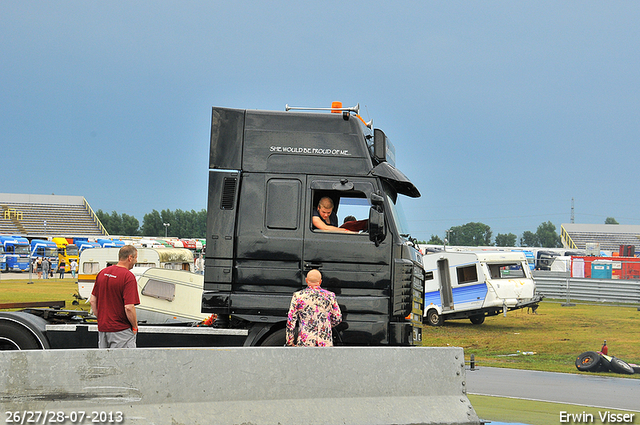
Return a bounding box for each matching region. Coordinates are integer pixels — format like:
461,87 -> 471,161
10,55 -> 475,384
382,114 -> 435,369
0,193 -> 107,239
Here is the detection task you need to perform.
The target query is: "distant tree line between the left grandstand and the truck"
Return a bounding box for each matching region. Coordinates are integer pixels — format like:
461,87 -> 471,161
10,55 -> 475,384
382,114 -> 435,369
96,209 -> 207,238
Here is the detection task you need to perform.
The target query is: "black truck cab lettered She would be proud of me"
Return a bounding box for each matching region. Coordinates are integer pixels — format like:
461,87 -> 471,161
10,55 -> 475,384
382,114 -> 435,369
202,107 -> 424,345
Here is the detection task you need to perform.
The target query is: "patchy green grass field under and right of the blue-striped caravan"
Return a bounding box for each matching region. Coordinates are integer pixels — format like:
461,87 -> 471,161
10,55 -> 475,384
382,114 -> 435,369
422,300 -> 640,379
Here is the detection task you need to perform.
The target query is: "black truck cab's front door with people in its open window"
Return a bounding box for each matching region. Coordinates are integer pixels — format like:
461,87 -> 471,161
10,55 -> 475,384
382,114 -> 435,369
303,176 -> 393,344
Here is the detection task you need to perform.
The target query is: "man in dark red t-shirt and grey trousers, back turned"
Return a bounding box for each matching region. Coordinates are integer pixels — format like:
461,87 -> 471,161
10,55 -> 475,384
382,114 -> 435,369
89,245 -> 140,348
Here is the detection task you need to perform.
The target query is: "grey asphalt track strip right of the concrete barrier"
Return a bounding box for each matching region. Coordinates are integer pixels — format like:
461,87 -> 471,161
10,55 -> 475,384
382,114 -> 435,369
466,367 -> 640,412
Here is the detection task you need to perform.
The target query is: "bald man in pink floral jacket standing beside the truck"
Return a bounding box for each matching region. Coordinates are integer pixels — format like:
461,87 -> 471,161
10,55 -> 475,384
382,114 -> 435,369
287,269 -> 342,347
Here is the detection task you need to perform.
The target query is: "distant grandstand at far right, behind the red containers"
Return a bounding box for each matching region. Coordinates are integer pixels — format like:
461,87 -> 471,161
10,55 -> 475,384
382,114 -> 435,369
561,223 -> 640,252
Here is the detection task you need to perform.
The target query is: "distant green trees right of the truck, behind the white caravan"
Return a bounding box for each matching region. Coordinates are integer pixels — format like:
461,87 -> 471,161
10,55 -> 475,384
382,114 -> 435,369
419,217 -> 619,248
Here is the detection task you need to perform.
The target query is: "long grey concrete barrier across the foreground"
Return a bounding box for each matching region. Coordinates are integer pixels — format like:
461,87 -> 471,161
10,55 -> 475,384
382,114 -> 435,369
0,347 -> 481,425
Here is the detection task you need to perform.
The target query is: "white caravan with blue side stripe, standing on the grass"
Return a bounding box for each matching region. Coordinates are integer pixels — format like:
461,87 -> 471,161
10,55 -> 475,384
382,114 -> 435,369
422,251 -> 542,326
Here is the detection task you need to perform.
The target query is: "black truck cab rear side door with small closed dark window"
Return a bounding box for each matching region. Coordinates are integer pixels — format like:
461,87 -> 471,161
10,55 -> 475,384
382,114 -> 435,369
231,173 -> 306,318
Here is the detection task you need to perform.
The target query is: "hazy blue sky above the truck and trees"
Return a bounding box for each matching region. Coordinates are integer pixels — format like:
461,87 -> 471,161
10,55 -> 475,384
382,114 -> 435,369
0,0 -> 640,239
